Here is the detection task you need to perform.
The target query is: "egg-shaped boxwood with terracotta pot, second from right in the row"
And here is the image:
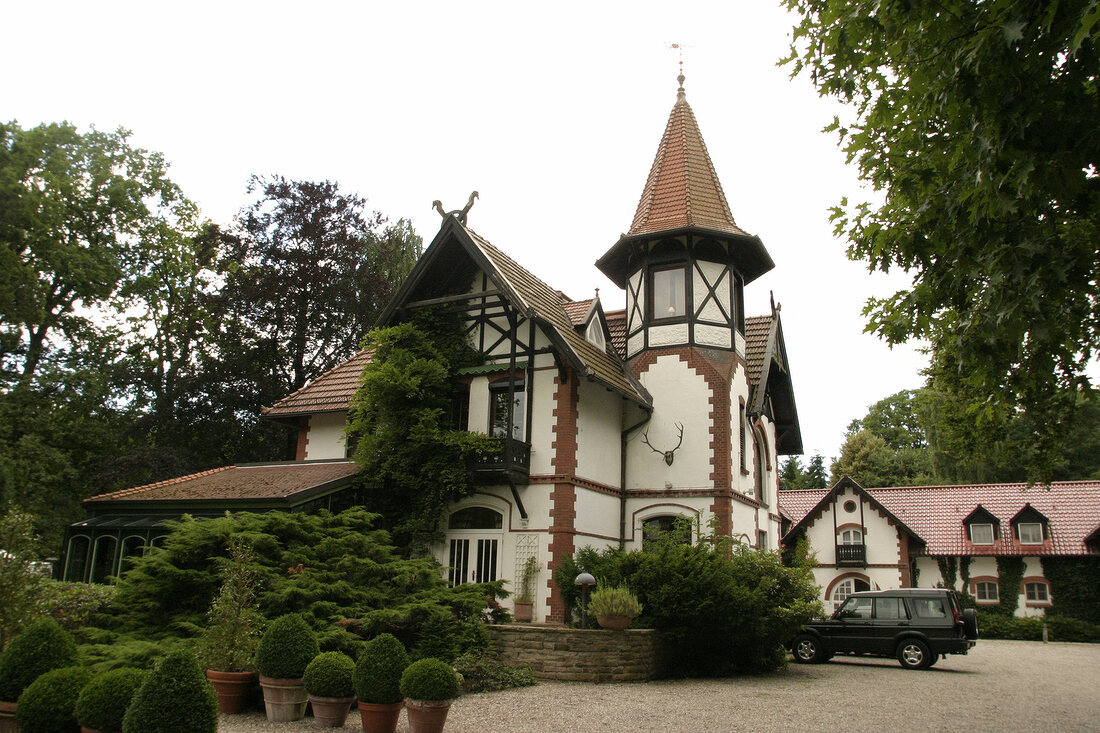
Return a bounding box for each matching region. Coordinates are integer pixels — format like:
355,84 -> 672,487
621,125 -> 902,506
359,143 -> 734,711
352,634 -> 409,733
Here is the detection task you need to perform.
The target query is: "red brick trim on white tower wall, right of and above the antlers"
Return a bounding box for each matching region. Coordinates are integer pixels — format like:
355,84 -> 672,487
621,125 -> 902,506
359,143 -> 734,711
630,347 -> 744,535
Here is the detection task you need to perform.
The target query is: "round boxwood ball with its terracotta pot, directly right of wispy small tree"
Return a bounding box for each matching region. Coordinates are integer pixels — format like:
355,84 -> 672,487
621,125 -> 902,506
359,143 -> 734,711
256,613 -> 320,723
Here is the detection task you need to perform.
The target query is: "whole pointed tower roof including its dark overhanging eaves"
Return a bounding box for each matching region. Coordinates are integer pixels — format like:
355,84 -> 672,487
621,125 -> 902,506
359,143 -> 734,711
596,76 -> 776,287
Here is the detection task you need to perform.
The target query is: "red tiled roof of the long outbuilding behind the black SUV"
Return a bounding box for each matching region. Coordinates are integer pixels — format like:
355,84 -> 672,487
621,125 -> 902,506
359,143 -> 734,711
779,481 -> 1100,556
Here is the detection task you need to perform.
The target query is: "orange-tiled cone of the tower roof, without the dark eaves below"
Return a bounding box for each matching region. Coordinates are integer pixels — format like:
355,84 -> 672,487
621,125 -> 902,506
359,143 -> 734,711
627,82 -> 748,237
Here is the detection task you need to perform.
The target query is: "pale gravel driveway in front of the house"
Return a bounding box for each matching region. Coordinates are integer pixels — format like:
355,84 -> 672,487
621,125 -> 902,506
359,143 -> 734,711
218,641 -> 1100,733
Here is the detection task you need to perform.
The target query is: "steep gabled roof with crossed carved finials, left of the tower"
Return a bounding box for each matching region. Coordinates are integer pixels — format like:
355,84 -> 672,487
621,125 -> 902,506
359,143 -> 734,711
378,216 -> 652,407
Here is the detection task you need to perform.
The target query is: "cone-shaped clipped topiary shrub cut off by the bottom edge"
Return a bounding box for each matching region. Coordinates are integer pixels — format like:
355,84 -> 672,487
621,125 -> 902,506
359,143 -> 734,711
122,652 -> 218,733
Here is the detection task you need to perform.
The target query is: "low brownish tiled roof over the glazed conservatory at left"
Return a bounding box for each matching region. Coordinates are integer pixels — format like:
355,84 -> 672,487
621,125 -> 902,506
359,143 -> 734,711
84,461 -> 356,504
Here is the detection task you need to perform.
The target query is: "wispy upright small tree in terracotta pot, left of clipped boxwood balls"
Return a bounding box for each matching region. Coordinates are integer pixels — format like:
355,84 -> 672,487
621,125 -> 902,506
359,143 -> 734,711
199,537 -> 264,714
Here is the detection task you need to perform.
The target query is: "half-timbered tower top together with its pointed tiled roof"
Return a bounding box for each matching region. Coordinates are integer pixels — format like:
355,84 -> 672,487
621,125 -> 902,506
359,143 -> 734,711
596,74 -> 774,360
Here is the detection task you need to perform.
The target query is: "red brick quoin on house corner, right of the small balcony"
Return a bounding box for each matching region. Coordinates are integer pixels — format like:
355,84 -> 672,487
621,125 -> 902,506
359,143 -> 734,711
547,370 -> 580,623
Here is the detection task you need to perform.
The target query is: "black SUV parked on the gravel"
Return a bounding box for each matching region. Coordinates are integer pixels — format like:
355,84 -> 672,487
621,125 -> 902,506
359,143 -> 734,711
790,588 -> 978,669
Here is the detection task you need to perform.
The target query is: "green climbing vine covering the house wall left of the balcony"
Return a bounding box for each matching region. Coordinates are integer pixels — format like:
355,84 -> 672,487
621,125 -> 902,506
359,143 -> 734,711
348,309 -> 498,547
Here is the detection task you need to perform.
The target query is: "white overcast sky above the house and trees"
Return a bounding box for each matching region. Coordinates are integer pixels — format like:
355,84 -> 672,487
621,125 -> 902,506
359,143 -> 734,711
0,0 -> 925,458
